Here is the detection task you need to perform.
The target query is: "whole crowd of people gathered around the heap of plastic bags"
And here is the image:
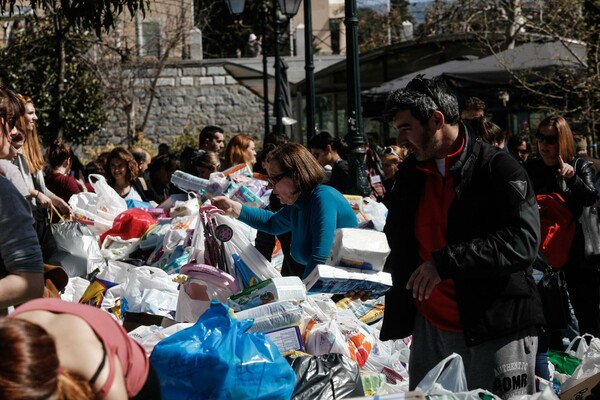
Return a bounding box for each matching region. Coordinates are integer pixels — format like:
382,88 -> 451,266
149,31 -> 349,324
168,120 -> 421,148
0,72 -> 600,399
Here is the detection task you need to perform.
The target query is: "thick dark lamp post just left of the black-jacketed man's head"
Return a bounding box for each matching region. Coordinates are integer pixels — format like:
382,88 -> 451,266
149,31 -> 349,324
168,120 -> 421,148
344,0 -> 370,197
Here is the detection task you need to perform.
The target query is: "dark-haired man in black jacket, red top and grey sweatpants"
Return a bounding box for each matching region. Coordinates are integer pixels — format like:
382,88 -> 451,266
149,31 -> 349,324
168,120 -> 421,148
381,76 -> 544,398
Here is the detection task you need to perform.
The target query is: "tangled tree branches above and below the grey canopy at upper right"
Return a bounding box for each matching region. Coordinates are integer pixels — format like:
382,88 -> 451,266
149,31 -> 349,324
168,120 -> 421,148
418,0 -> 600,140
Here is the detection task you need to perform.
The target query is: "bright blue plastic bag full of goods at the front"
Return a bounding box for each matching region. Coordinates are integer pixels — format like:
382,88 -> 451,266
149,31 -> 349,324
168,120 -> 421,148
150,301 -> 296,400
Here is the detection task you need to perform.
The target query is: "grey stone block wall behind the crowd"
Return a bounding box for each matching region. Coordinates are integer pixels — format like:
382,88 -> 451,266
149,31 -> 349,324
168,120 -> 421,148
90,59 -> 264,152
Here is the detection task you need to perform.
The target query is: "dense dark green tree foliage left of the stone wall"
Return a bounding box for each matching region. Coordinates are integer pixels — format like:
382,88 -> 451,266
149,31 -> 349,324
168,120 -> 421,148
0,19 -> 105,144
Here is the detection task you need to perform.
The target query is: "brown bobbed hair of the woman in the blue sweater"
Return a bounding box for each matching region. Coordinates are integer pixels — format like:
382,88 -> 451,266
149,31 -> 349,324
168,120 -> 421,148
267,143 -> 325,194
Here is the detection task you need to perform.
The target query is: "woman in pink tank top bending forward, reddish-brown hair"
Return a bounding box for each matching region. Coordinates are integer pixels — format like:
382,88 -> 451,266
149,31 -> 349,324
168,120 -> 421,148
0,299 -> 161,400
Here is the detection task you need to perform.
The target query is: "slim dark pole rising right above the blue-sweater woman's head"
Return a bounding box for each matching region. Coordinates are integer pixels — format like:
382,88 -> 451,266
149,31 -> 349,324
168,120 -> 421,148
304,0 -> 317,146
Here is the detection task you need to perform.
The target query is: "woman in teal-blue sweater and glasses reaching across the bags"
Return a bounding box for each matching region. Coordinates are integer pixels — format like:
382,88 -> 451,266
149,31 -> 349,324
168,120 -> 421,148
212,143 -> 357,278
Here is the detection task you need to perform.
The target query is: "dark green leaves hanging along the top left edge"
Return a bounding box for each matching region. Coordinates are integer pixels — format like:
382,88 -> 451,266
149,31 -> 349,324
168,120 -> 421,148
0,0 -> 150,36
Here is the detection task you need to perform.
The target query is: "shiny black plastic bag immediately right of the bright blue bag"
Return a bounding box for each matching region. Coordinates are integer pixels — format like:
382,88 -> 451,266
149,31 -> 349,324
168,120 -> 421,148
288,353 -> 364,400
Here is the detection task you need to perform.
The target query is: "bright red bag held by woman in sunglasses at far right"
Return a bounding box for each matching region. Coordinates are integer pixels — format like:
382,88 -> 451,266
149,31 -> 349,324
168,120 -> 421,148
537,193 -> 575,268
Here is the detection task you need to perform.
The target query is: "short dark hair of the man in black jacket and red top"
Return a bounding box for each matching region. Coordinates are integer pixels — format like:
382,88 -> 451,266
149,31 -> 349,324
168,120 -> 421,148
384,75 -> 460,125
